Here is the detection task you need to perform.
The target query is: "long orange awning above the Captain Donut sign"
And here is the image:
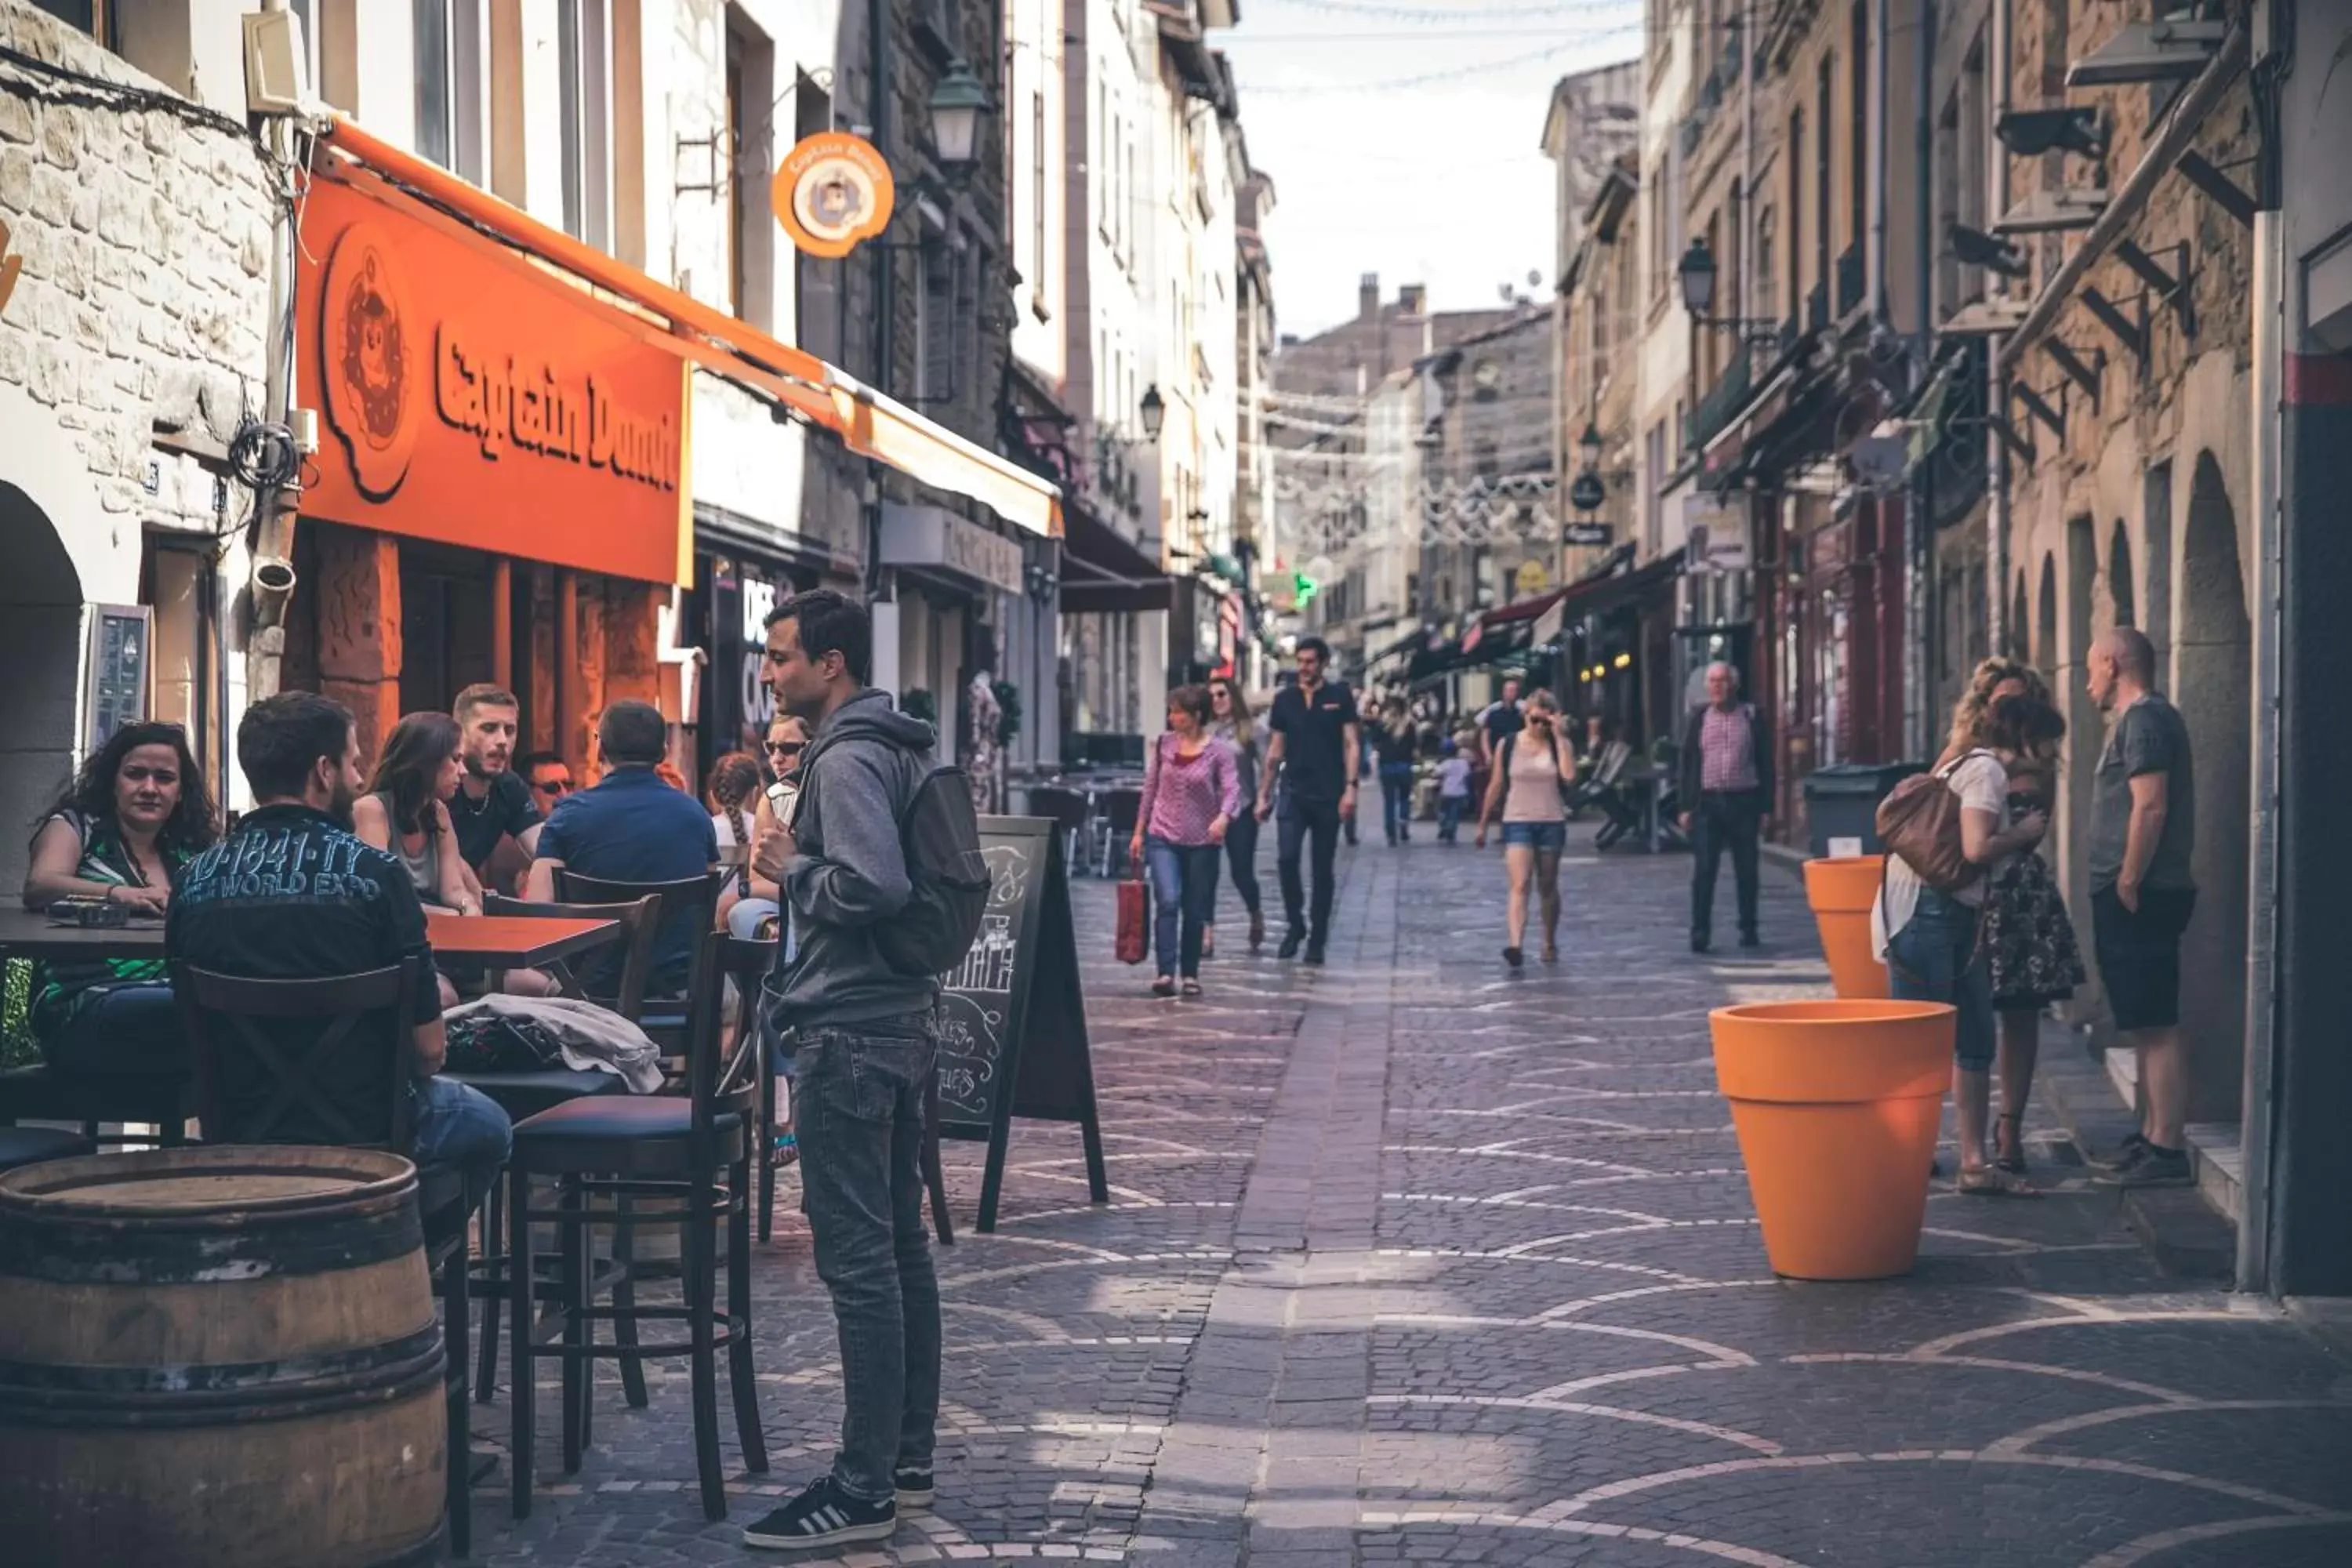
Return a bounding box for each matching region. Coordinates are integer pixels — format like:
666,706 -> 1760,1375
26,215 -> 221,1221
315,115 -> 1063,539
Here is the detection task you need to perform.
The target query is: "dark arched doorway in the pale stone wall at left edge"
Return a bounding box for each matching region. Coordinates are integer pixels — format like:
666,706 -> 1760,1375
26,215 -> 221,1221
0,482 -> 82,898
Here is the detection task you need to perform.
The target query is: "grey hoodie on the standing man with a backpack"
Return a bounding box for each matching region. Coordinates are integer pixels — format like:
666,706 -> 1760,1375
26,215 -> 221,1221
771,689 -> 938,1029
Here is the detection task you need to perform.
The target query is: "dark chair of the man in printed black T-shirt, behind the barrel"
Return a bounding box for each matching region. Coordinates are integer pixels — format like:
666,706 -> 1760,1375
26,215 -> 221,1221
172,959 -> 485,1556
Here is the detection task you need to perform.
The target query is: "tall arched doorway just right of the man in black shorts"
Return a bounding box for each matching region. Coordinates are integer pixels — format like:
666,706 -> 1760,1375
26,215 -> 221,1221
2171,452 -> 2253,1121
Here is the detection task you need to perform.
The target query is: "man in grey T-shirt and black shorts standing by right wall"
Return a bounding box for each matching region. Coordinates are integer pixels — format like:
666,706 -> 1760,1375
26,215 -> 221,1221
2089,626 -> 2197,1187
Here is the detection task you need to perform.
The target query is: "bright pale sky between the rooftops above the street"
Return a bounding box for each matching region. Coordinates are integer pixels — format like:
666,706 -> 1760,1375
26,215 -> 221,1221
1211,0 -> 1642,336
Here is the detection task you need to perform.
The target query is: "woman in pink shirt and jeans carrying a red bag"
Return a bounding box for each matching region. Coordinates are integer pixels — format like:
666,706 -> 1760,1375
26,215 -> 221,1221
1127,687 -> 1242,996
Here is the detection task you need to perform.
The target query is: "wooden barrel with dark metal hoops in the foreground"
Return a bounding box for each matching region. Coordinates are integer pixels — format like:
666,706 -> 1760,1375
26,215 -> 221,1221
0,1147 -> 449,1568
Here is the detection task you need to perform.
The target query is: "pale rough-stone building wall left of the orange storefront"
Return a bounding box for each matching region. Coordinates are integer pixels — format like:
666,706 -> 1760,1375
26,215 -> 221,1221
0,0 -> 282,886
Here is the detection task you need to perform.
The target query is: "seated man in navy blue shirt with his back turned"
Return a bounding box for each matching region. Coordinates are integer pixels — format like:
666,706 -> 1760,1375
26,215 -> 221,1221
527,703 -> 720,994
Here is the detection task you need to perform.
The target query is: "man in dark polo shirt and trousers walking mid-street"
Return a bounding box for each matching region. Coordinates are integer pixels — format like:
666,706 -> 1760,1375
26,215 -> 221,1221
1258,637 -> 1364,964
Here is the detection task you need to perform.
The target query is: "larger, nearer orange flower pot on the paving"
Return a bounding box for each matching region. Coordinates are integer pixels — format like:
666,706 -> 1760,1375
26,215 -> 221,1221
1708,996 -> 1955,1279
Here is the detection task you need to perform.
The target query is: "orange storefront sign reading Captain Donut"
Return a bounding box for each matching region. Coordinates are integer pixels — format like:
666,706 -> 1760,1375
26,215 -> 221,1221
296,176 -> 691,583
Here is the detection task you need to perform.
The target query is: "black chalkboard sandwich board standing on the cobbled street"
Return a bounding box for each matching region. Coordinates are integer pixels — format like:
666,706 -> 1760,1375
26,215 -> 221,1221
938,815 -> 1110,1232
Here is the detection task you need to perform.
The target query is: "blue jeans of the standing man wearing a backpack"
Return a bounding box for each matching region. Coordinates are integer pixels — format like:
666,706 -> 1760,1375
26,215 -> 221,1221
793,1013 -> 938,1502
